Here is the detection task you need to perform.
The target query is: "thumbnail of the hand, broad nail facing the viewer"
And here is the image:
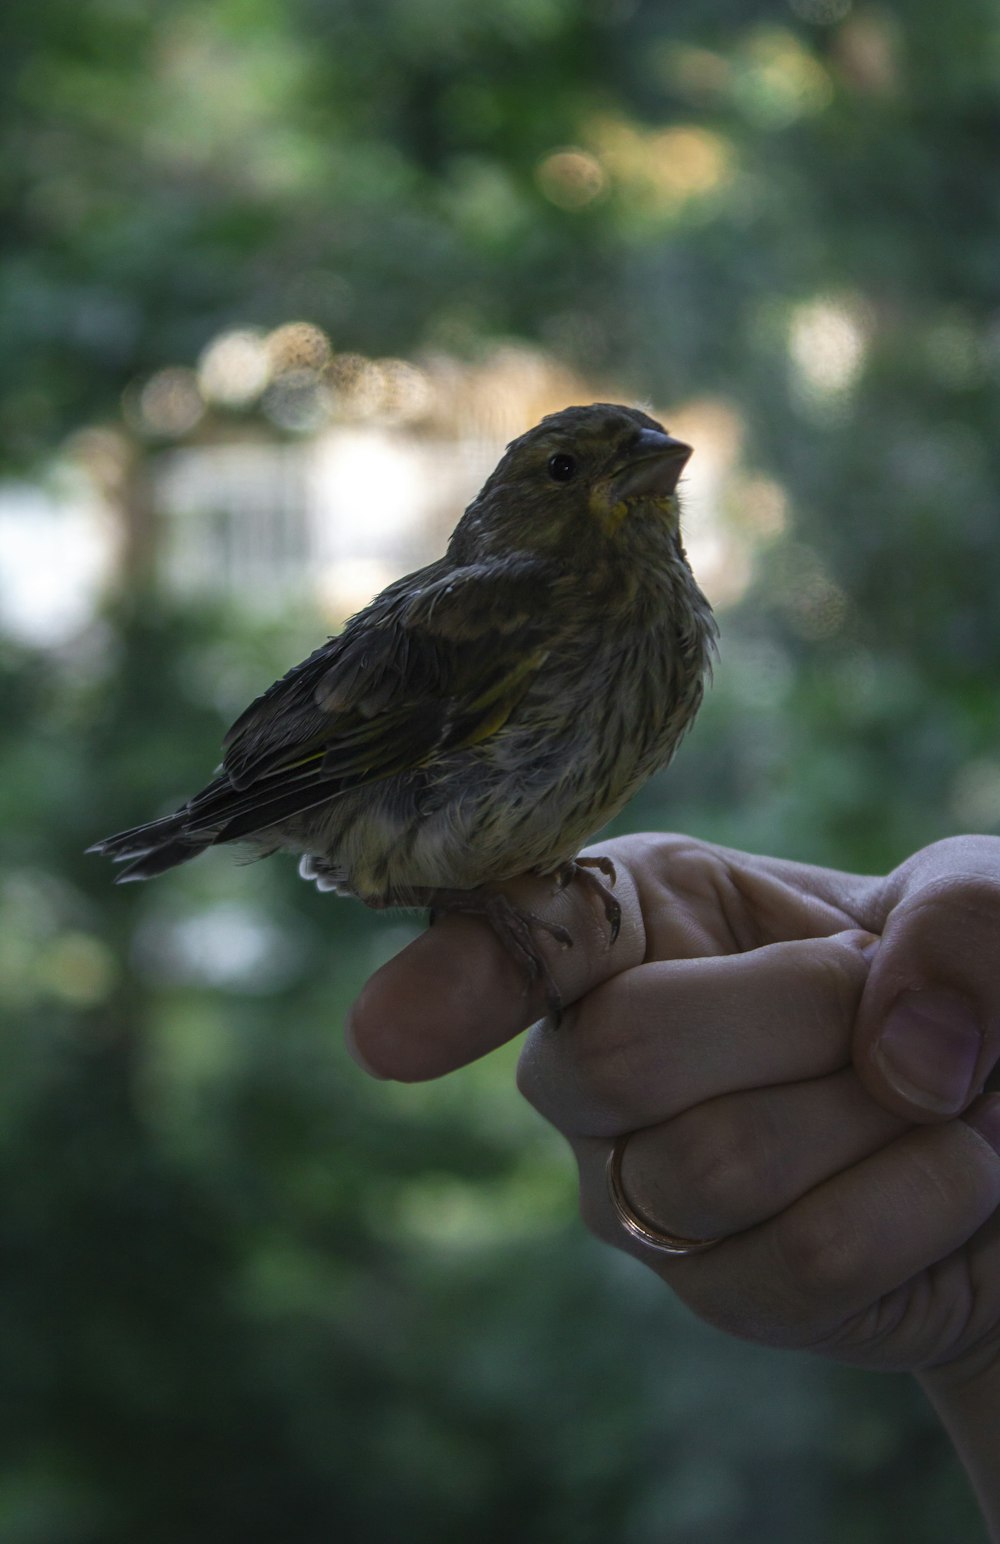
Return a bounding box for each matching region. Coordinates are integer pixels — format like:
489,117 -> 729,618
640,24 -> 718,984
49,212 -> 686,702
873,991 -> 983,1115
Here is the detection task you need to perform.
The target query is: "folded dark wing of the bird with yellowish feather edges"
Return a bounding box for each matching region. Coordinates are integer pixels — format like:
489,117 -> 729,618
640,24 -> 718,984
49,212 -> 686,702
222,560 -> 557,794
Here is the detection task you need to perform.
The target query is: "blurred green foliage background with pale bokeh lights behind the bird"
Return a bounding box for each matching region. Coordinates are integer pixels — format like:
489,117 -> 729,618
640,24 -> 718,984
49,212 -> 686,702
0,0 -> 1000,1544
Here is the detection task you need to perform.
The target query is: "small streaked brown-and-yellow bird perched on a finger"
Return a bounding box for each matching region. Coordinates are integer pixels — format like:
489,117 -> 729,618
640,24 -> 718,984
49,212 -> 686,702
90,403 -> 716,1016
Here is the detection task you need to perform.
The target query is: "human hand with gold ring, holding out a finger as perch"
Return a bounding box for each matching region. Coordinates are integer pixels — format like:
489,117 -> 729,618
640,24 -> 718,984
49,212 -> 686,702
352,837 -> 1000,1368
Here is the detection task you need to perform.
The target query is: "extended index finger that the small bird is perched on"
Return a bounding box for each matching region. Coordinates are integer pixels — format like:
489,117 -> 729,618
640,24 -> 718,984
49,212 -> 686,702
347,851 -> 645,1082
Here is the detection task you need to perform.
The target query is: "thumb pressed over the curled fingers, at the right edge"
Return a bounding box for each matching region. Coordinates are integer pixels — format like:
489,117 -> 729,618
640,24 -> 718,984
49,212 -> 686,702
853,837 -> 1000,1121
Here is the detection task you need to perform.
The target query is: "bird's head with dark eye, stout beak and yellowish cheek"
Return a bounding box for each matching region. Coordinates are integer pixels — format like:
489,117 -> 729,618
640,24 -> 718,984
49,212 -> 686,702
455,401 -> 691,562
